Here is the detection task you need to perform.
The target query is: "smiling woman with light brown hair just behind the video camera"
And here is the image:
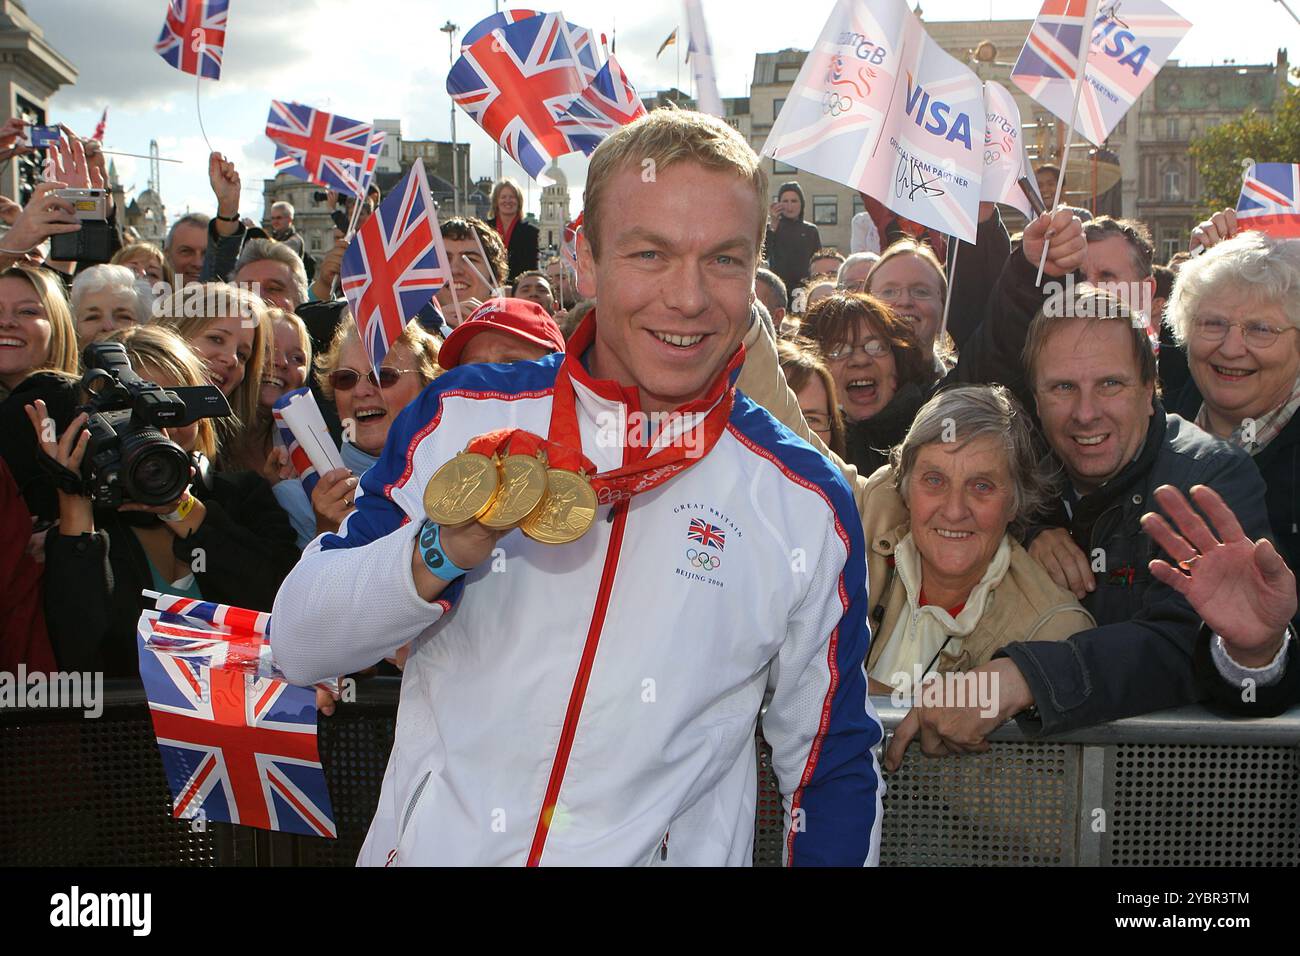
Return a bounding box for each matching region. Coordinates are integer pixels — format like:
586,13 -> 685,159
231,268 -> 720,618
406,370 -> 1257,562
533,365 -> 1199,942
155,282 -> 274,447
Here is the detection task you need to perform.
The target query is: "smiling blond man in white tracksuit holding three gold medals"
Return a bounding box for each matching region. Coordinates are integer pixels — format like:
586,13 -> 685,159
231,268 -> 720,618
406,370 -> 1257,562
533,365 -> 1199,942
272,109 -> 883,865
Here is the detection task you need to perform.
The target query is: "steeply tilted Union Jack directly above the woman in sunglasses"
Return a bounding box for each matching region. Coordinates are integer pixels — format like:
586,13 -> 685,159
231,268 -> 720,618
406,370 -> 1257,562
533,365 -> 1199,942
342,160 -> 451,368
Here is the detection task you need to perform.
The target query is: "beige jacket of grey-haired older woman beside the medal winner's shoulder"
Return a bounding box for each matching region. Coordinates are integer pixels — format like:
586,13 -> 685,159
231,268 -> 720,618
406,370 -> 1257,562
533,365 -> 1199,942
736,323 -> 1096,671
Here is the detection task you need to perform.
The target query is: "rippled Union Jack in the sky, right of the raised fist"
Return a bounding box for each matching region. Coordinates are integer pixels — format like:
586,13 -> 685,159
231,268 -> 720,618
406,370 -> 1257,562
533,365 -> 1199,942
267,100 -> 382,193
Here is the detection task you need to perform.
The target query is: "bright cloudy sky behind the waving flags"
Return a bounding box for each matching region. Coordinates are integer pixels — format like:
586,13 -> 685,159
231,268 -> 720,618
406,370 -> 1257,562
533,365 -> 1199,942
25,0 -> 1300,219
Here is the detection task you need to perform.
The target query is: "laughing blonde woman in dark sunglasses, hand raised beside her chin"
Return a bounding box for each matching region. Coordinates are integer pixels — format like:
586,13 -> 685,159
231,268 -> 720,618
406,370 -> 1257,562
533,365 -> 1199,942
312,316 -> 442,535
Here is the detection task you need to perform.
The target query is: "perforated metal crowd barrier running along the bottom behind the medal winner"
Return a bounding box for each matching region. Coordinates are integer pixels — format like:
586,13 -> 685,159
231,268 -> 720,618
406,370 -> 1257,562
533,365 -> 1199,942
0,678 -> 1300,866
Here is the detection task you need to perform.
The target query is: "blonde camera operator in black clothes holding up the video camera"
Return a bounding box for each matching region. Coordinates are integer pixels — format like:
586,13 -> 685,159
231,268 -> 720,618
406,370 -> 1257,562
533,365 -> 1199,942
27,326 -> 298,678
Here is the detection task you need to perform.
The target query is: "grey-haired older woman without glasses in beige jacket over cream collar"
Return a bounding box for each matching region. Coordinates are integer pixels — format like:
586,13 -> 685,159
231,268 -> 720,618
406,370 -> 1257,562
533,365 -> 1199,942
862,385 -> 1093,695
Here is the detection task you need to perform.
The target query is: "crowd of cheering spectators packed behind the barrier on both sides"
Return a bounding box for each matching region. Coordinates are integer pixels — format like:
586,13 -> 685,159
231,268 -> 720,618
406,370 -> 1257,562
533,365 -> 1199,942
0,110 -> 1300,763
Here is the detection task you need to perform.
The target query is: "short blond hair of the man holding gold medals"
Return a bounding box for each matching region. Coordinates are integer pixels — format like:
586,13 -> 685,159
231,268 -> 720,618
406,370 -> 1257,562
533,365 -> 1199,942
582,107 -> 767,256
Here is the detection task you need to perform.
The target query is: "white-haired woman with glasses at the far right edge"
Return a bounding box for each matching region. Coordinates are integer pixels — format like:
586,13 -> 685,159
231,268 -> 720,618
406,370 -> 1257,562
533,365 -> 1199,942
1165,232 -> 1300,580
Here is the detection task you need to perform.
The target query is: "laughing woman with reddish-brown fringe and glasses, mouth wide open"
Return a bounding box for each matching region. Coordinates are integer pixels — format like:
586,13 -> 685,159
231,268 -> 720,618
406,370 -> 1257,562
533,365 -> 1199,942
802,293 -> 939,475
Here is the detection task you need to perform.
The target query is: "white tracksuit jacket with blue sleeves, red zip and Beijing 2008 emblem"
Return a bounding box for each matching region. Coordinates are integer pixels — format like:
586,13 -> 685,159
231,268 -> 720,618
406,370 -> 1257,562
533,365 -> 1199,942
273,317 -> 884,865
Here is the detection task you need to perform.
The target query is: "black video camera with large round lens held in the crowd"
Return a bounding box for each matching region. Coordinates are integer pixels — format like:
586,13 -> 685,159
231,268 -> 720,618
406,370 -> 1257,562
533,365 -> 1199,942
79,342 -> 231,507
